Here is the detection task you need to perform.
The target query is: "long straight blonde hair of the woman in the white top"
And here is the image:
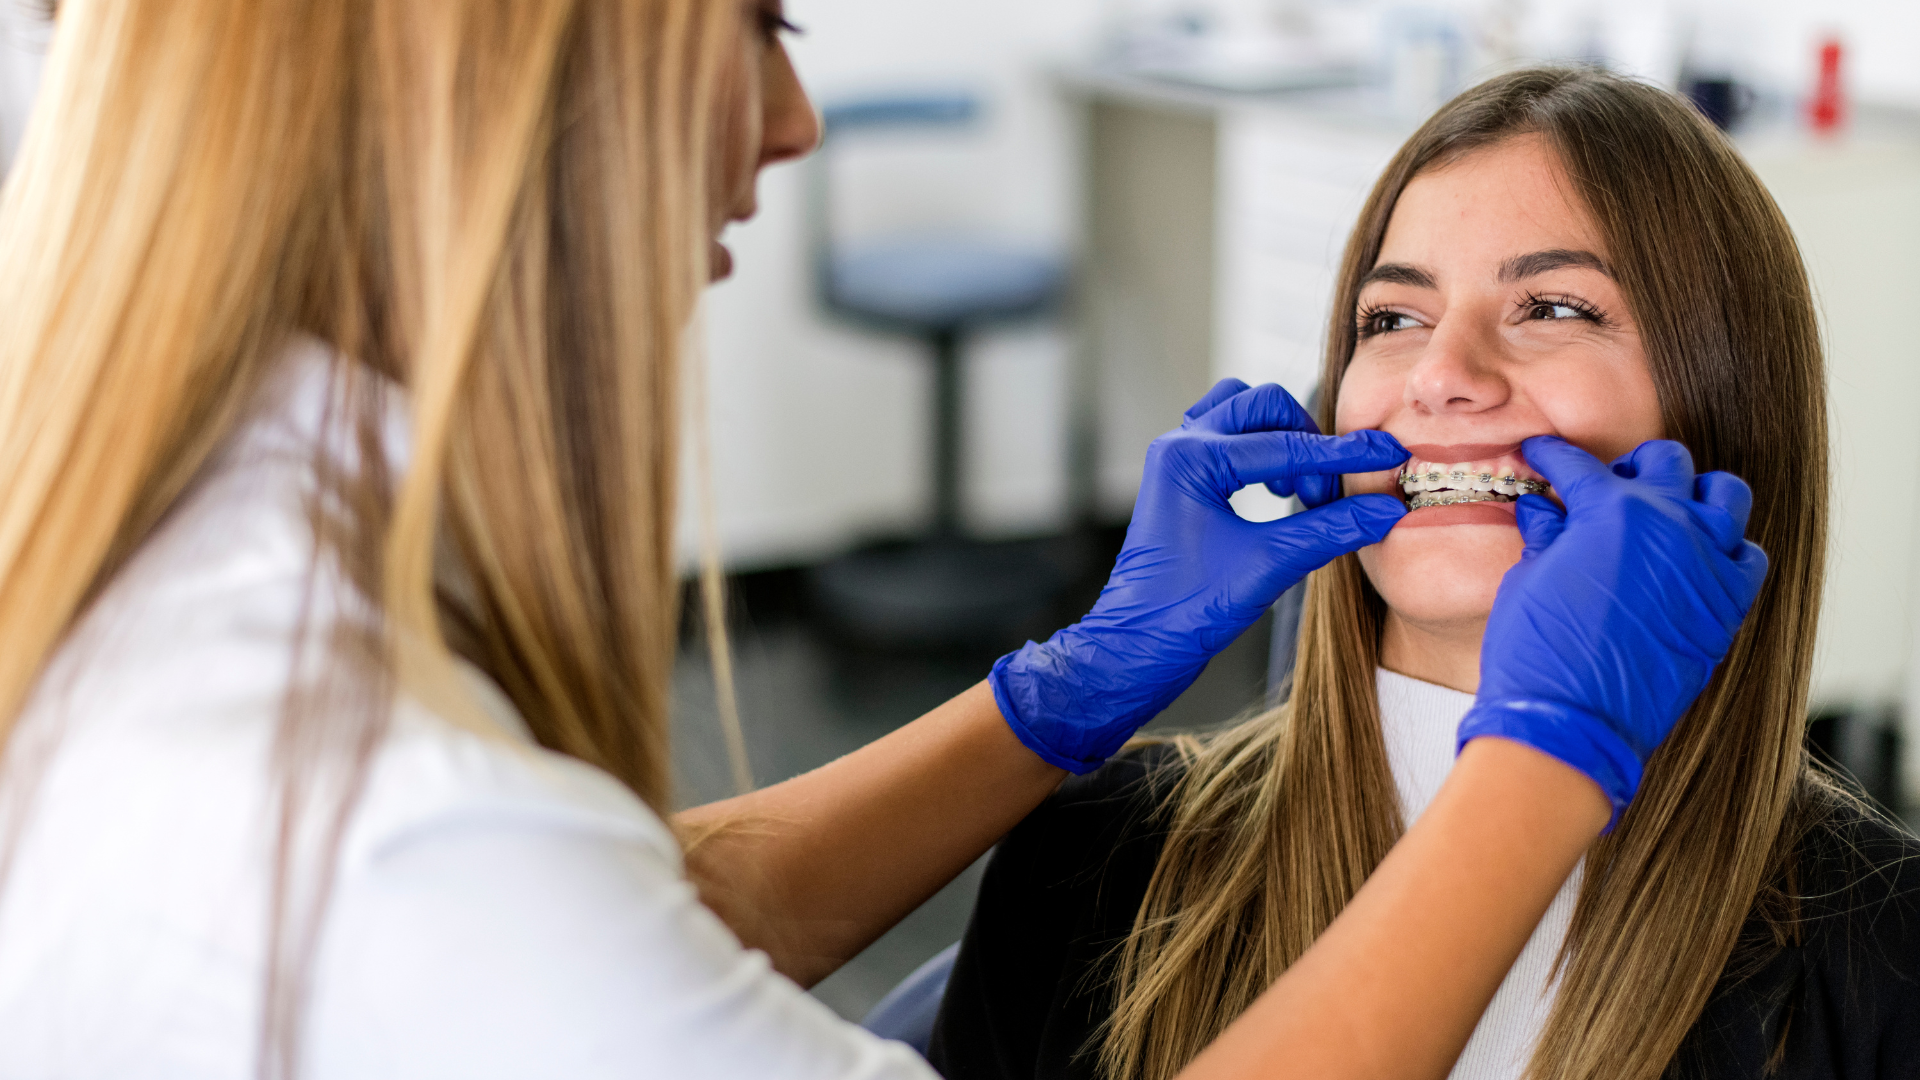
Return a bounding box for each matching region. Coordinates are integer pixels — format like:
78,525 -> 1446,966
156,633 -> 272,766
0,0 -> 741,1072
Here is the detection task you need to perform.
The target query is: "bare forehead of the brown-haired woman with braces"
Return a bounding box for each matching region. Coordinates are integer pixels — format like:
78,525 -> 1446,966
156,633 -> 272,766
1379,135 -> 1607,274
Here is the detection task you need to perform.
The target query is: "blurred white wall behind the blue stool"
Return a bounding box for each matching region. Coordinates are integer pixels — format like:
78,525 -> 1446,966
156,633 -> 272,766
682,0 -> 1098,567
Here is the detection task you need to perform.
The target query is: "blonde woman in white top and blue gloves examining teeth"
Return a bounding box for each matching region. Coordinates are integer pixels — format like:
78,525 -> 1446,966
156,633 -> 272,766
0,8 -> 1764,1080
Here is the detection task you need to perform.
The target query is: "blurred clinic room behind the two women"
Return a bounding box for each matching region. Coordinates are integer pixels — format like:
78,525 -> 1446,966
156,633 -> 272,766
0,0 -> 1920,1019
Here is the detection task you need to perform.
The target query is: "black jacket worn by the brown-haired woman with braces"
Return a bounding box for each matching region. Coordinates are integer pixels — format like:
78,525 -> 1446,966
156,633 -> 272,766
929,748 -> 1920,1080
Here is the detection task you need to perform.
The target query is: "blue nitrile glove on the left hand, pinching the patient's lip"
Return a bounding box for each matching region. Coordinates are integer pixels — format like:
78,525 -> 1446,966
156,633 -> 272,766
987,379 -> 1407,773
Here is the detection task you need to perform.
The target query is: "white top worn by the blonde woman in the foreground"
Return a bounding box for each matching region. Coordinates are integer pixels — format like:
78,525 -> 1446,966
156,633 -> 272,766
0,340 -> 933,1080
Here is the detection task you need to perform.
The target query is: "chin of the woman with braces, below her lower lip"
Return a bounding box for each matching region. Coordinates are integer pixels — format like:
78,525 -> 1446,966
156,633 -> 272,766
1359,525 -> 1523,632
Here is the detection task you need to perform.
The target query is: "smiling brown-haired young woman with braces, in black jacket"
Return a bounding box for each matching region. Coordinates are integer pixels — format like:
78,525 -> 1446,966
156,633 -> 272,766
931,69 -> 1920,1080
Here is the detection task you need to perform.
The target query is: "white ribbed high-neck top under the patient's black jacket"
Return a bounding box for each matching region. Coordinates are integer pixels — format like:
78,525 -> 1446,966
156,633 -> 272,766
1375,667 -> 1586,1080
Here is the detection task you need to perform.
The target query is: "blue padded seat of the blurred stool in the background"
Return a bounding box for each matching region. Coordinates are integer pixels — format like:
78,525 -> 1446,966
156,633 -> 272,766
826,238 -> 1066,329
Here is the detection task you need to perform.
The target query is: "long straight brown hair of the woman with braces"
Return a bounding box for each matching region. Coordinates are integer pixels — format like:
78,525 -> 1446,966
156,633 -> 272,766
1098,69 -> 1828,1080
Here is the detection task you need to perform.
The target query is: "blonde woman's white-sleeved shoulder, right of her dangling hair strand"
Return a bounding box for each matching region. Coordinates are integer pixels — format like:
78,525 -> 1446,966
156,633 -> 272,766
313,680 -> 931,1080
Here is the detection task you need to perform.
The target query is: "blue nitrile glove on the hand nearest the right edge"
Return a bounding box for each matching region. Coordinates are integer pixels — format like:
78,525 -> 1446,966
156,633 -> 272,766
1459,436 -> 1766,830
